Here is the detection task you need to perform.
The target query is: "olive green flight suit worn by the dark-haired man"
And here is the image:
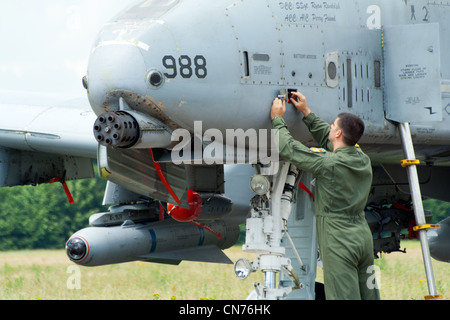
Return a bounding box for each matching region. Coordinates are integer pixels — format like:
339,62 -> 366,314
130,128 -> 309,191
272,113 -> 380,300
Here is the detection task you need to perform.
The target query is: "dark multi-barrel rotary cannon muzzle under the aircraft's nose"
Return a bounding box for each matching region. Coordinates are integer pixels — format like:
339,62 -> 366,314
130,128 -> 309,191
94,111 -> 139,148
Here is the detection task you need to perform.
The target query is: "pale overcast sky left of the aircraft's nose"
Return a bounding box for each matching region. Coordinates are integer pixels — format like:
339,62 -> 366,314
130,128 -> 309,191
0,0 -> 137,95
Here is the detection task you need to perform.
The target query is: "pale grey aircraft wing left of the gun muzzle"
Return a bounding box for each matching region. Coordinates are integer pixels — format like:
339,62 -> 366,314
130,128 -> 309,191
0,92 -> 97,186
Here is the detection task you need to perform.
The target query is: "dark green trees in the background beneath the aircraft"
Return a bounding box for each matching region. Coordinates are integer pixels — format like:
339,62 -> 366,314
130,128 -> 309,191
0,172 -> 450,251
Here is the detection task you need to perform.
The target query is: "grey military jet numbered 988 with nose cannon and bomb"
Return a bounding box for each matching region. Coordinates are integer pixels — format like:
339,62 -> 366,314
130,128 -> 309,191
0,0 -> 450,299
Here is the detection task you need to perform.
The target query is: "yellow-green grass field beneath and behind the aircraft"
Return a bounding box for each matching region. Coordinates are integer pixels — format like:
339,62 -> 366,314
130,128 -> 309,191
0,241 -> 450,300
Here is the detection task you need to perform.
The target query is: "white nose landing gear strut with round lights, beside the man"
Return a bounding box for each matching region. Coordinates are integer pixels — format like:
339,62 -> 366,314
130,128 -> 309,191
235,162 -> 317,299
